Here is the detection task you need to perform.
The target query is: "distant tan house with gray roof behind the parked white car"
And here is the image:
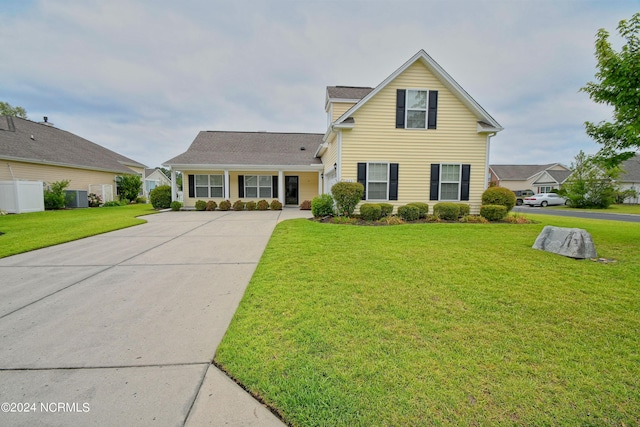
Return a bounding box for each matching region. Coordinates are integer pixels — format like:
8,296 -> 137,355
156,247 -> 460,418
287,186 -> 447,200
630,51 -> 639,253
489,163 -> 571,193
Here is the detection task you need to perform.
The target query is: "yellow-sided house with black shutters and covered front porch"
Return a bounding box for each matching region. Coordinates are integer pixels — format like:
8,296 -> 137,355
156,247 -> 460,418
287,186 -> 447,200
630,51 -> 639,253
164,51 -> 502,212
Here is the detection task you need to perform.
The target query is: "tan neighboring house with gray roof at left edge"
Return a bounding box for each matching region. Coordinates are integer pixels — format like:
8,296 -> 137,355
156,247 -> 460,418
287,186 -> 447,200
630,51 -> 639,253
0,116 -> 145,201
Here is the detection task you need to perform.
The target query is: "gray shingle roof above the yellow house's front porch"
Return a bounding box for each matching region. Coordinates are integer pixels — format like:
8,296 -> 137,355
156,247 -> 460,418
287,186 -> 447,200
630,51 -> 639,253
164,131 -> 323,166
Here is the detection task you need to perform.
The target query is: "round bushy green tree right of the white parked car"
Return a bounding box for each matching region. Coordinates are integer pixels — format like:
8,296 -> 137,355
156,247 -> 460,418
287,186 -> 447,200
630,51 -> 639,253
558,151 -> 619,209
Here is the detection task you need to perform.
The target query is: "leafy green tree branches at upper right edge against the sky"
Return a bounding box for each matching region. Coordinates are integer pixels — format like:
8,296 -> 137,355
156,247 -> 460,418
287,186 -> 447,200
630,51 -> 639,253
580,12 -> 640,167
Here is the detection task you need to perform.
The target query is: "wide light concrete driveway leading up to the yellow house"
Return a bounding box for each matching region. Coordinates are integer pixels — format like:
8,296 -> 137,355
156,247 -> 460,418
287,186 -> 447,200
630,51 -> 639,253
0,209 -> 310,427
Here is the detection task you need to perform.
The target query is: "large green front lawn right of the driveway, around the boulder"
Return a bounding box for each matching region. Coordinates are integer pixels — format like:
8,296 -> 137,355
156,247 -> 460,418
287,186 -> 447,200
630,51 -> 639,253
215,215 -> 640,426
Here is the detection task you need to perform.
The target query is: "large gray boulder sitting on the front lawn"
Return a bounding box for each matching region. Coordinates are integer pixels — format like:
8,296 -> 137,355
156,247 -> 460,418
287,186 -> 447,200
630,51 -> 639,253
533,225 -> 598,259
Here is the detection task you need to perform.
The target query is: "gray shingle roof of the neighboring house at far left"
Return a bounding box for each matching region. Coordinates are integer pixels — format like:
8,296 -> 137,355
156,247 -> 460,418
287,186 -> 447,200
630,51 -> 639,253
0,116 -> 144,173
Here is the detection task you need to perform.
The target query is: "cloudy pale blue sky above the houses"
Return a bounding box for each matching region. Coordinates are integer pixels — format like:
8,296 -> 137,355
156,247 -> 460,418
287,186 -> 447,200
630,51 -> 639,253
0,0 -> 640,166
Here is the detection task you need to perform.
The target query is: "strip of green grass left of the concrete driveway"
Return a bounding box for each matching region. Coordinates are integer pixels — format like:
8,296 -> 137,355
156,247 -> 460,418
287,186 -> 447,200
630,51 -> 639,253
0,204 -> 155,258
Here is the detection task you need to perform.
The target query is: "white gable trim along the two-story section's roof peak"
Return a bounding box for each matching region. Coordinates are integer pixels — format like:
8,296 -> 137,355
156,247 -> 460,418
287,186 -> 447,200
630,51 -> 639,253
334,50 -> 503,132
